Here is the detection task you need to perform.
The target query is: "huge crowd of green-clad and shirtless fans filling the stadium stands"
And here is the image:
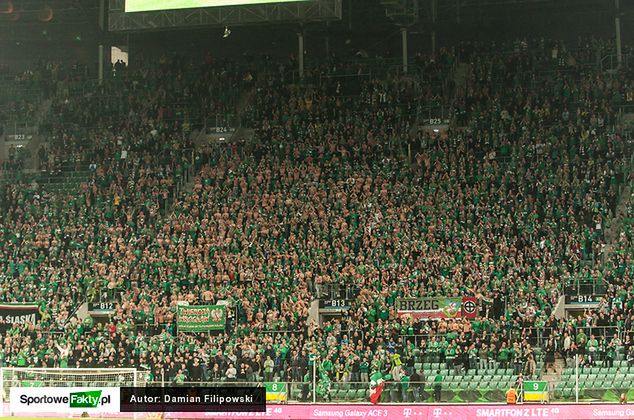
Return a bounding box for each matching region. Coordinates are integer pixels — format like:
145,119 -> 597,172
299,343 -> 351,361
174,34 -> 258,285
0,37 -> 634,396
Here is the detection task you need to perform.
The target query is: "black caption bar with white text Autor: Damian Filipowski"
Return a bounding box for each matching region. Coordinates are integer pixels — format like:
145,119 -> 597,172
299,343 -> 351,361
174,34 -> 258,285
120,387 -> 266,413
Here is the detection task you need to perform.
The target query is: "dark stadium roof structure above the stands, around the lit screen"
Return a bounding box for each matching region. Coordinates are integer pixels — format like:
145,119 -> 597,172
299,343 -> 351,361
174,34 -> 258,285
0,0 -> 634,50
